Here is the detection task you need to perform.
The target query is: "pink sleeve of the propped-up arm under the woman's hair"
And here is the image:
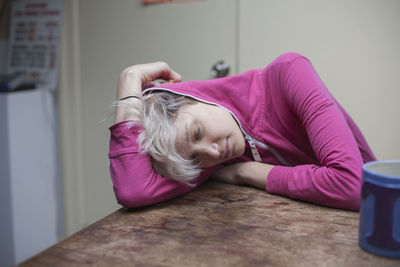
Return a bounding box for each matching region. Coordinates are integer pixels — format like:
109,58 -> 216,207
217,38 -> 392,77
109,122 -> 209,207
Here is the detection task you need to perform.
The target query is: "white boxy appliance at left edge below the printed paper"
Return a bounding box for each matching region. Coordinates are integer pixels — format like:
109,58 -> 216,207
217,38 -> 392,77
0,89 -> 63,266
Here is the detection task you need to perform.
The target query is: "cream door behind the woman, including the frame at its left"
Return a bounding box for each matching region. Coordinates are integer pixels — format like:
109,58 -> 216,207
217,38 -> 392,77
60,0 -> 237,234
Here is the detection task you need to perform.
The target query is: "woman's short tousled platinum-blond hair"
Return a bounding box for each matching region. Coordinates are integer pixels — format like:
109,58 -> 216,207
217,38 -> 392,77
121,92 -> 201,186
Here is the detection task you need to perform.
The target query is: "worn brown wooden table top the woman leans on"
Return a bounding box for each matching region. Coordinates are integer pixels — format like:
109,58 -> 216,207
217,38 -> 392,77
21,181 -> 400,267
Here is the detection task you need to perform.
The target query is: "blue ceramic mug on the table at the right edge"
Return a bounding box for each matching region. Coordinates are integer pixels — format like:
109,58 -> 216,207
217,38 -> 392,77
359,160 -> 400,258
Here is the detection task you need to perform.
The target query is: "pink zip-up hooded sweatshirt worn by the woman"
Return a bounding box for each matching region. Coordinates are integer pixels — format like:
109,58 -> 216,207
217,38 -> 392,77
109,53 -> 376,210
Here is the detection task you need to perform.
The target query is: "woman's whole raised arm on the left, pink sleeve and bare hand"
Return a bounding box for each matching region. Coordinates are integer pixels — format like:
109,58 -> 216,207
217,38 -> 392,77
109,62 -> 211,207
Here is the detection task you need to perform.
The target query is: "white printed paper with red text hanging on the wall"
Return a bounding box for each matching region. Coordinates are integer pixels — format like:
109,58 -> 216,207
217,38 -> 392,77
7,0 -> 62,90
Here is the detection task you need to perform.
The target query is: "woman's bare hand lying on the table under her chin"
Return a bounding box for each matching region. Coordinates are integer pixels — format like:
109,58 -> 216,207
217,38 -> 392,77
211,161 -> 274,190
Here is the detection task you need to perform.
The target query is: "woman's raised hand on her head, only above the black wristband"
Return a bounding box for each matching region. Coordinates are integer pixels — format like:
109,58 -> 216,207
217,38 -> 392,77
117,61 -> 182,99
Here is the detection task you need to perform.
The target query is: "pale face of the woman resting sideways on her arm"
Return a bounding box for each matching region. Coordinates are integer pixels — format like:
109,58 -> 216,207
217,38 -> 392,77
173,102 -> 245,168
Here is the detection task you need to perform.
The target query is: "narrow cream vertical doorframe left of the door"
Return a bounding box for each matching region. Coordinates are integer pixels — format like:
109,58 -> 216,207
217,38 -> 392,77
58,0 -> 86,236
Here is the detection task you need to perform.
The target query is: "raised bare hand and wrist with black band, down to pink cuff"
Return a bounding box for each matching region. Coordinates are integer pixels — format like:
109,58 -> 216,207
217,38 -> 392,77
114,61 -> 182,123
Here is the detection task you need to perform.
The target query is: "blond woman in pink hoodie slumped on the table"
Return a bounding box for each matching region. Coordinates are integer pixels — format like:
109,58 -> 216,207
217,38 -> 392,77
109,53 -> 375,210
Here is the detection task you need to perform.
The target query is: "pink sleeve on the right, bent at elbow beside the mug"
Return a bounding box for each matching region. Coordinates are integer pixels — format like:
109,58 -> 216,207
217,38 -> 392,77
266,55 -> 363,210
